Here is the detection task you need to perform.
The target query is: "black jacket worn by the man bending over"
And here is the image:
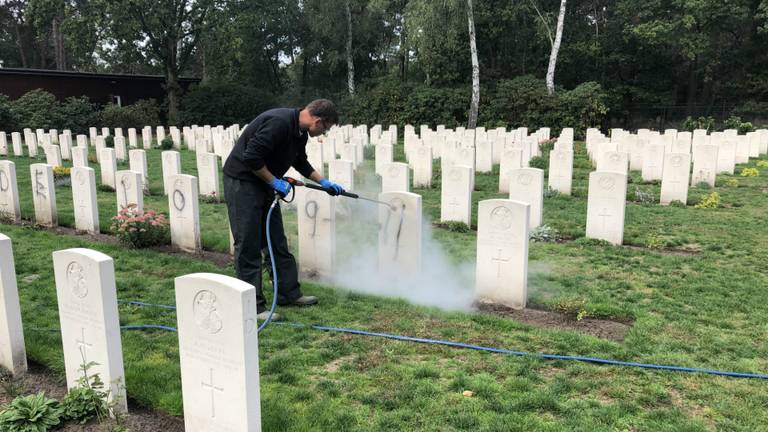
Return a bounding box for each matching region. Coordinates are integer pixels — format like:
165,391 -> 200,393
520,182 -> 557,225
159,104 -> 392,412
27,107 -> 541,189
224,108 -> 315,184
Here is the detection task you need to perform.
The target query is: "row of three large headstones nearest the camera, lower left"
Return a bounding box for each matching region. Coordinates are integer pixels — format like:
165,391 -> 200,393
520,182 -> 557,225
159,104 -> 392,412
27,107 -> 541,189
0,234 -> 261,432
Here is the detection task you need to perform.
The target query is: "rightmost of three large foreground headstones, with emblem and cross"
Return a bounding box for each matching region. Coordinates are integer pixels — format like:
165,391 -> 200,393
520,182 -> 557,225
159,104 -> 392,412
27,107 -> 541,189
175,273 -> 261,432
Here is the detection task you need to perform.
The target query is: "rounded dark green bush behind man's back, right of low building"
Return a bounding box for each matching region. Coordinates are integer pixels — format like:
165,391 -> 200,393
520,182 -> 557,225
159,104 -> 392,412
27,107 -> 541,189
179,83 -> 274,125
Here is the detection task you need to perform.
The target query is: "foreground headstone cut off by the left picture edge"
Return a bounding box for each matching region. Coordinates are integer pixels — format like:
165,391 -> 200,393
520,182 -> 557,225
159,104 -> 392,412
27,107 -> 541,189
0,234 -> 27,375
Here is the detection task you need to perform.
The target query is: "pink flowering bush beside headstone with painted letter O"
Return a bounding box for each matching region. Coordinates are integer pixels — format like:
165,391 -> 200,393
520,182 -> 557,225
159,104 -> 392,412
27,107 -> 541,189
112,204 -> 170,248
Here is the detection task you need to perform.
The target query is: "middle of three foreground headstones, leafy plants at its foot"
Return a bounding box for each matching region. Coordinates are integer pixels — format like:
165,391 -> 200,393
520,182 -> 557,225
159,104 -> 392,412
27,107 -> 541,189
53,248 -> 128,411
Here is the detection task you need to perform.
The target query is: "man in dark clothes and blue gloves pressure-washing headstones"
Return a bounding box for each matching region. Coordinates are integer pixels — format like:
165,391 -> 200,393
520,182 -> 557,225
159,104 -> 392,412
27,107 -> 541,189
224,99 -> 343,320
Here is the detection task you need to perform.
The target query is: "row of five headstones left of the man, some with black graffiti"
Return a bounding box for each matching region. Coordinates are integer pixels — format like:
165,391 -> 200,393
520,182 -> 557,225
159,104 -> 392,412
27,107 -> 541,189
0,160 -> 201,252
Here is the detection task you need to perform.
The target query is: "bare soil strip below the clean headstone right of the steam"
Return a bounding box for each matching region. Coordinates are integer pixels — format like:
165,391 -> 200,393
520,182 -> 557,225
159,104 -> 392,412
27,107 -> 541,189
475,302 -> 632,341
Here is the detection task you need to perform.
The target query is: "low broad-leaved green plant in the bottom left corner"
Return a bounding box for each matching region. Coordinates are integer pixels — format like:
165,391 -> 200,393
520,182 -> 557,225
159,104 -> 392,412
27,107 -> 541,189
0,392 -> 64,432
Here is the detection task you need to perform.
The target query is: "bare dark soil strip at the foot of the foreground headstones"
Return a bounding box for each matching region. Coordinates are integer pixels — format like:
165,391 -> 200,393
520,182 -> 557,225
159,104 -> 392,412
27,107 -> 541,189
0,362 -> 184,432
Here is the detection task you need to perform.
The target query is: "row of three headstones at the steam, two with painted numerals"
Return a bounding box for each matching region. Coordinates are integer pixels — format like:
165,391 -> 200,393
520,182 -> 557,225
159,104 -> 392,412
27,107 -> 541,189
296,189 -> 532,307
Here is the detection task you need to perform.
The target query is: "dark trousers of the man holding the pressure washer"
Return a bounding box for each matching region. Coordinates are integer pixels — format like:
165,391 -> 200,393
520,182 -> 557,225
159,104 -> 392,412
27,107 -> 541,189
224,175 -> 301,313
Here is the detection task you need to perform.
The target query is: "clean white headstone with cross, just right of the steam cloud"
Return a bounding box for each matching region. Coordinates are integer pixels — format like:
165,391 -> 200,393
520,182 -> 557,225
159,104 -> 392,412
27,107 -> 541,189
475,199 -> 530,309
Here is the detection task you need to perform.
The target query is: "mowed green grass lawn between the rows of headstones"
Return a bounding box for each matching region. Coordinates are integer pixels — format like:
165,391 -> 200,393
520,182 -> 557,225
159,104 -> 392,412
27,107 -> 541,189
1,143 -> 768,431
